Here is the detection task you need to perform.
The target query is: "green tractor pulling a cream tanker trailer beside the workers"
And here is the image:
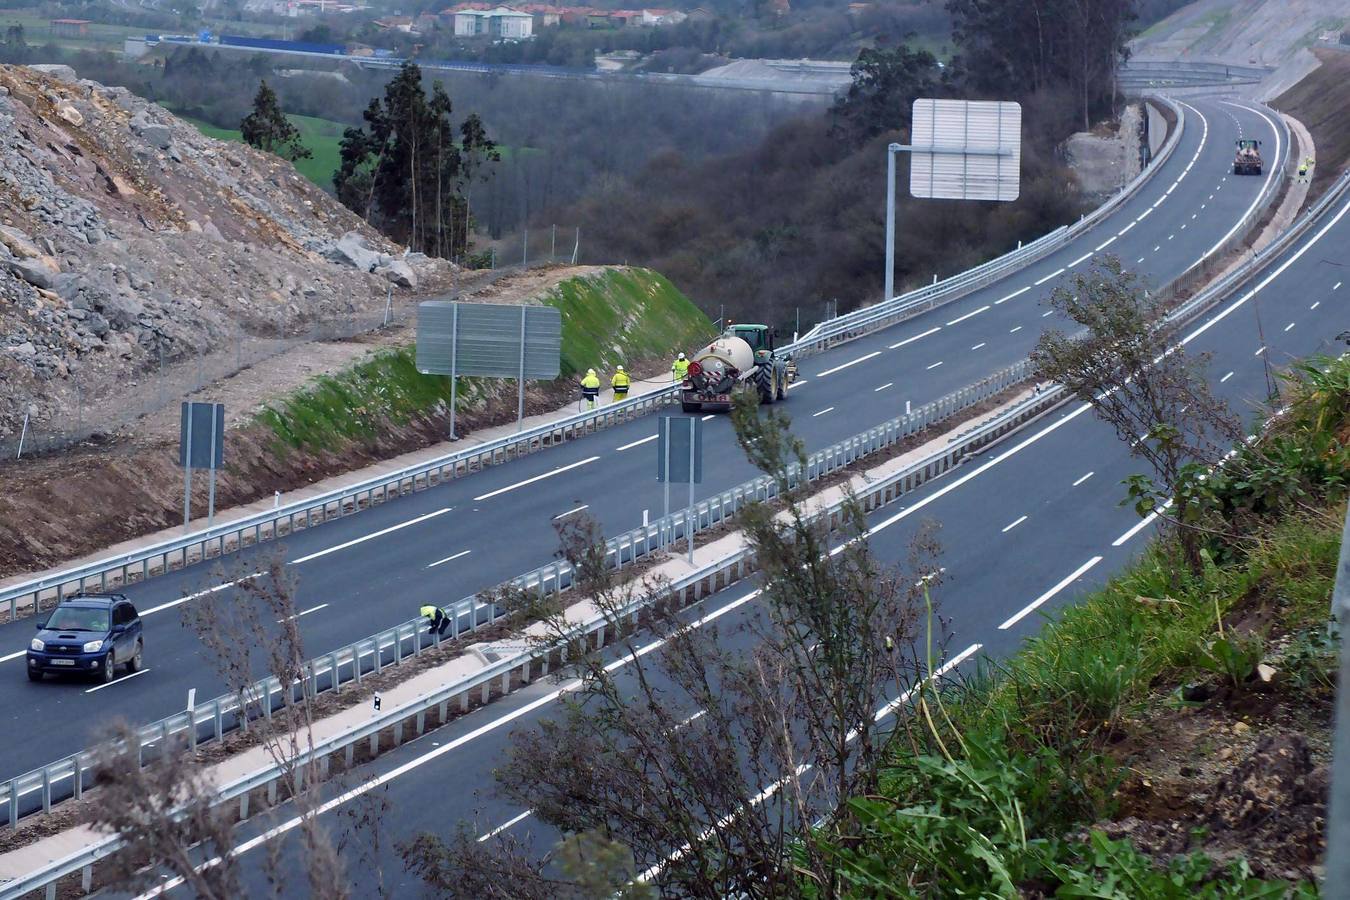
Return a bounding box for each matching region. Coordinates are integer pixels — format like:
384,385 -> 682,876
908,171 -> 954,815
680,325 -> 797,413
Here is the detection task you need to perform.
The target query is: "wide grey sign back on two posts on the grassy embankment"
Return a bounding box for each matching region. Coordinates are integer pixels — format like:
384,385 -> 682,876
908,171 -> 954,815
417,300 -> 563,378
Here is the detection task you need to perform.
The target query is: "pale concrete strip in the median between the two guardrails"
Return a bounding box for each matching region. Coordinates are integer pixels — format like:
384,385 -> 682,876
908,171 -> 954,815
0,390 -> 1064,897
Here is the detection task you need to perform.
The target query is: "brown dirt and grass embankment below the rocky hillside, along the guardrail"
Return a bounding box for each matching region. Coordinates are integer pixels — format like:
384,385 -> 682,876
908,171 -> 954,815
0,267 -> 710,578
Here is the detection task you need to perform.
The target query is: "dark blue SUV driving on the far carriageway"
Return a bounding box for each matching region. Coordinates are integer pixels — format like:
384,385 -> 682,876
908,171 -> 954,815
28,594 -> 144,684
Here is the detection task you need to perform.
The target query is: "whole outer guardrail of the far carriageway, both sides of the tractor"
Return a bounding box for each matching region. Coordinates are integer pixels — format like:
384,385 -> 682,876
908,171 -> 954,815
0,99 -> 1184,619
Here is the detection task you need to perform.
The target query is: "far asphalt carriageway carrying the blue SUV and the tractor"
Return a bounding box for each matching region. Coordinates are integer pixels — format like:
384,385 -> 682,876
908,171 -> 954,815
0,100 -> 1284,793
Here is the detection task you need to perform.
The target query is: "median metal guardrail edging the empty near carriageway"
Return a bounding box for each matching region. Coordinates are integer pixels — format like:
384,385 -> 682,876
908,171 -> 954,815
0,356 -> 1062,900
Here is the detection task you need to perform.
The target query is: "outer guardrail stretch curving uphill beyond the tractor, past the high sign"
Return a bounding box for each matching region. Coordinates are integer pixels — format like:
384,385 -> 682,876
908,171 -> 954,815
797,96 -> 1185,349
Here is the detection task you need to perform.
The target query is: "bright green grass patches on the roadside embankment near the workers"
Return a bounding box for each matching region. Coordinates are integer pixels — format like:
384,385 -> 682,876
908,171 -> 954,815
258,269 -> 713,451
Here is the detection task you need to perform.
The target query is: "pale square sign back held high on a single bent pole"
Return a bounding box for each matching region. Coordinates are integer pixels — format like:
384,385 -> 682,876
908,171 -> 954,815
910,99 -> 1022,200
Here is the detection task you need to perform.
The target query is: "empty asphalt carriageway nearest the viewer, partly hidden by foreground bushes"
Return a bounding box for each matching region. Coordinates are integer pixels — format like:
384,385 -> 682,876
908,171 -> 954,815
160,147 -> 1350,896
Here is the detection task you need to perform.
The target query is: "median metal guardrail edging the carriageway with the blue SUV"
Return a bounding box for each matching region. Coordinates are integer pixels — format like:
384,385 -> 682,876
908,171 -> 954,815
0,360 -> 1031,828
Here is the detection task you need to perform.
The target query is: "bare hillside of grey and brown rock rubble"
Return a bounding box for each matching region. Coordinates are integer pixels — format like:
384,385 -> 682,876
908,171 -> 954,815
0,66 -> 451,443
